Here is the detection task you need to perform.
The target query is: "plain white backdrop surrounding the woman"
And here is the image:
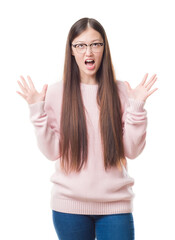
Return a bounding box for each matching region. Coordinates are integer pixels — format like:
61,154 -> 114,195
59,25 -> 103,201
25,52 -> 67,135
0,0 -> 175,240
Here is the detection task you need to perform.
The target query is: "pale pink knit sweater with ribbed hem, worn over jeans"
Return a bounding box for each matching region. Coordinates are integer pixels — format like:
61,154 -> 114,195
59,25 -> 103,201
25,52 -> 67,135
28,80 -> 147,215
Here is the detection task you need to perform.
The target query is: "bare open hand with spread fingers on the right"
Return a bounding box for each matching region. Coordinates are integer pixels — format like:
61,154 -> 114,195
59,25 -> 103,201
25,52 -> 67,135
124,73 -> 158,101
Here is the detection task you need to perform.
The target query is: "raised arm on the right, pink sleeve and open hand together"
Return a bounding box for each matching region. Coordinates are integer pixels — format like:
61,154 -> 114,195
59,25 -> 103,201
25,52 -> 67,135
122,74 -> 157,159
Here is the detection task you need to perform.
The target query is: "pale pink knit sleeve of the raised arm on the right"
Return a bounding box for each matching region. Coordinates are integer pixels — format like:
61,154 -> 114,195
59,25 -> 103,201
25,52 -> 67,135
122,98 -> 147,159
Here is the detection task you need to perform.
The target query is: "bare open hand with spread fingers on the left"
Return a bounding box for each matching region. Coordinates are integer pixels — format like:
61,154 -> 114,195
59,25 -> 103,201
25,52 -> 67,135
16,76 -> 48,104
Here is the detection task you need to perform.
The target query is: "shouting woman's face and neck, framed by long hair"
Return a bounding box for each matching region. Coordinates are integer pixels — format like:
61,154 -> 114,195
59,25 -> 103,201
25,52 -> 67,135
72,27 -> 104,80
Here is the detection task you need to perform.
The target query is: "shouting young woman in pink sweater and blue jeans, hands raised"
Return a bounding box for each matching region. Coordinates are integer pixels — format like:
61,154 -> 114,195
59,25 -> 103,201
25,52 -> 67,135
17,18 -> 157,240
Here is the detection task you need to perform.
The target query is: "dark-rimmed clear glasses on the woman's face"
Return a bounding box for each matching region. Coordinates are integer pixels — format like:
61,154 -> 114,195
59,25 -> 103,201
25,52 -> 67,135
72,43 -> 104,53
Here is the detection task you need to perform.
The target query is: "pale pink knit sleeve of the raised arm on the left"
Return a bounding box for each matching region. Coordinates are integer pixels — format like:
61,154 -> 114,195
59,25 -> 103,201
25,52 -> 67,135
28,84 -> 60,161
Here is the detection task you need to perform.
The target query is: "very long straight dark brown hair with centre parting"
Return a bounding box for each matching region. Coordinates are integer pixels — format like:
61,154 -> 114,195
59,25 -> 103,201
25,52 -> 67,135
59,18 -> 126,173
